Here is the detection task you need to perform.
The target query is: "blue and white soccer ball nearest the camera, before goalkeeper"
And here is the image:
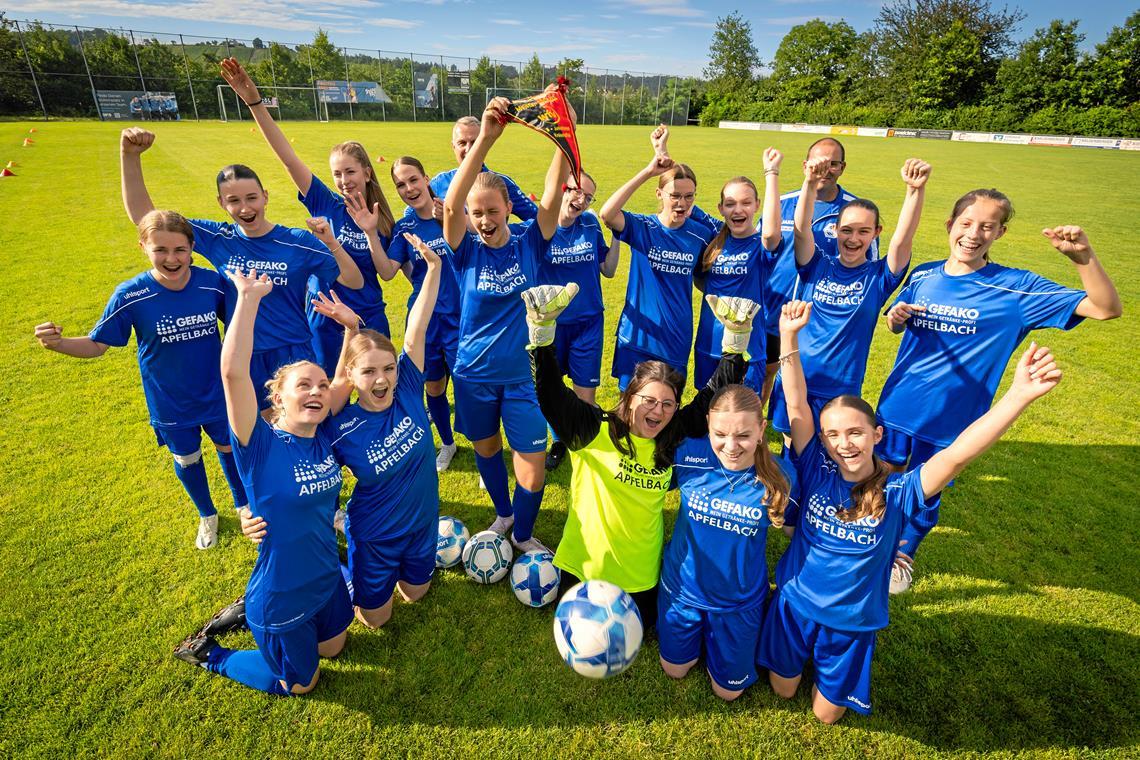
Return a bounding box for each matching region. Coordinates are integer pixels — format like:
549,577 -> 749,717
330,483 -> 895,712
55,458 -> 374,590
554,580 -> 642,678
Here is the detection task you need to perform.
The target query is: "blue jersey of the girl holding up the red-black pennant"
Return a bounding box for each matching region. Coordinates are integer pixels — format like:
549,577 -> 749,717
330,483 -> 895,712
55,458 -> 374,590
454,222 -> 551,384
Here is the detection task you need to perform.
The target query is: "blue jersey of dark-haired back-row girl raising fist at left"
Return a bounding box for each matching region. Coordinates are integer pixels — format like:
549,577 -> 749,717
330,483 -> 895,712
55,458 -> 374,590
190,219 -> 339,351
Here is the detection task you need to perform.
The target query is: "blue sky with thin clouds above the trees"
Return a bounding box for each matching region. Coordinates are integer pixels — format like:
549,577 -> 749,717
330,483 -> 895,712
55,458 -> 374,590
3,0 -> 1135,74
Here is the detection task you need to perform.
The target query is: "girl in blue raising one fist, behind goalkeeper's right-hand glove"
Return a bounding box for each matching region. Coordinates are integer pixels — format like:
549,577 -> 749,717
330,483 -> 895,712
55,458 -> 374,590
693,148 -> 783,392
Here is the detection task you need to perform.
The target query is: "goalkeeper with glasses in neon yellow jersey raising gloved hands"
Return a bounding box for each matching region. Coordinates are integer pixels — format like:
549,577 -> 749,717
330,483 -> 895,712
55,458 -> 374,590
522,284 -> 759,628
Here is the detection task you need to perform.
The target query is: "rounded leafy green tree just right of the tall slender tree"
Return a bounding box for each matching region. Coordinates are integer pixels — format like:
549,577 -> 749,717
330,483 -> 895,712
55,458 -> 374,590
772,18 -> 858,100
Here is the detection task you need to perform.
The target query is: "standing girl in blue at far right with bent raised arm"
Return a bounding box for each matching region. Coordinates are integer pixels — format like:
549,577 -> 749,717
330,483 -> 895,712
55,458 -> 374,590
878,190 -> 1123,593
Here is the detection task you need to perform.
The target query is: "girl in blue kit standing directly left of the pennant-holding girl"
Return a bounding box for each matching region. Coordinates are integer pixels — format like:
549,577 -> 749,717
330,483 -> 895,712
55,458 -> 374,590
388,156 -> 459,472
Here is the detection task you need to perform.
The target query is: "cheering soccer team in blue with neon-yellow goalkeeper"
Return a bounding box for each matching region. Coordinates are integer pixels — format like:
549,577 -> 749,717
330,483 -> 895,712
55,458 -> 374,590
35,59 -> 1122,722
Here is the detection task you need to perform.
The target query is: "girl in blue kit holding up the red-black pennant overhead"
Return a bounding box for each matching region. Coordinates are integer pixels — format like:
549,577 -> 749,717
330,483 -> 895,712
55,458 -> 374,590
443,85 -> 576,551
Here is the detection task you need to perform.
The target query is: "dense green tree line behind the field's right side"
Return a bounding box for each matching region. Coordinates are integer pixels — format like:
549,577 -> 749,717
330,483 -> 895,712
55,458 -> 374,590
700,0 -> 1140,137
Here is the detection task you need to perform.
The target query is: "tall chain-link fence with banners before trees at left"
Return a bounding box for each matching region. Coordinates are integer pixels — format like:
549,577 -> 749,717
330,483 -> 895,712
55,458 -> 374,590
0,19 -> 695,124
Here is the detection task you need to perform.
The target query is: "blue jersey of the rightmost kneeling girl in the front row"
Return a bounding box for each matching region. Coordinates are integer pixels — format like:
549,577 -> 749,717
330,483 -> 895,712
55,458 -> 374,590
776,436 -> 925,631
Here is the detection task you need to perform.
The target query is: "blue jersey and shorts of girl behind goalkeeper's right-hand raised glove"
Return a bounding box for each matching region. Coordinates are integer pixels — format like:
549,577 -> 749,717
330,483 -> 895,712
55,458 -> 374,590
693,232 -> 770,361
